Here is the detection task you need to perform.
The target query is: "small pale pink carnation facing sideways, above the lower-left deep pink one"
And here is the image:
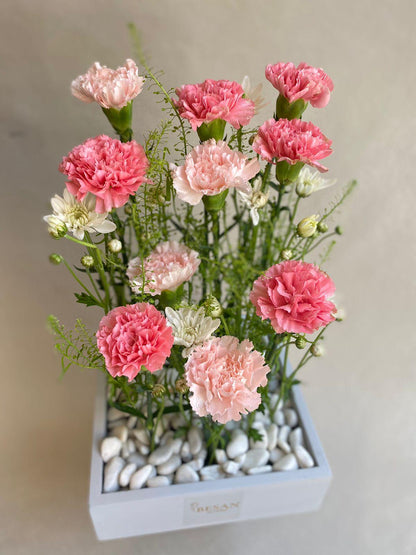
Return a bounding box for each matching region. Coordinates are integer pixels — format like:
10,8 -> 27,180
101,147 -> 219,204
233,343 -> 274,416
127,241 -> 201,296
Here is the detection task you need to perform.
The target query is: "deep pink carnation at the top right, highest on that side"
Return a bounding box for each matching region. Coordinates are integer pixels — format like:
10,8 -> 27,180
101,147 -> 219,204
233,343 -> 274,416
266,62 -> 334,108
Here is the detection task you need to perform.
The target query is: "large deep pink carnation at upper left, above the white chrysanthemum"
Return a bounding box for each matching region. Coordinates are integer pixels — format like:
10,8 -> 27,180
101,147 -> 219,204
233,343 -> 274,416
59,135 -> 149,214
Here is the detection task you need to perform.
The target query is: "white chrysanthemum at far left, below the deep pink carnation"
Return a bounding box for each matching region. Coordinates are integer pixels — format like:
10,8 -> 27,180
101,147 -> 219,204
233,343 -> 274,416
43,189 -> 116,239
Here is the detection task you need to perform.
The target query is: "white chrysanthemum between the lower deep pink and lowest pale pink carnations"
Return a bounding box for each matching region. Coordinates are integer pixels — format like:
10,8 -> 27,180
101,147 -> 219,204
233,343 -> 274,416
165,306 -> 221,357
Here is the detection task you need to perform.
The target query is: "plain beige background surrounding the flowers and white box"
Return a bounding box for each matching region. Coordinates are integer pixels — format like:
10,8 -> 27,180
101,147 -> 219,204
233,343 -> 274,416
0,0 -> 416,555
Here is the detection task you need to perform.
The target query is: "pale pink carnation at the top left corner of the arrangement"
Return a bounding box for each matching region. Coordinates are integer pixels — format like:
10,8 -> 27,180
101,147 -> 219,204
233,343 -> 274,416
71,59 -> 144,110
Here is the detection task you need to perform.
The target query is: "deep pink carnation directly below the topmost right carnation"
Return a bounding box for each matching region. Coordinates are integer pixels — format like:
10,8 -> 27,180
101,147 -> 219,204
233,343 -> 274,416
253,118 -> 332,172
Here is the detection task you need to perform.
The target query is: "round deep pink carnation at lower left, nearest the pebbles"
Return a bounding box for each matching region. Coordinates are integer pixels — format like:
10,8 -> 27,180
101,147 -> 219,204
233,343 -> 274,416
97,303 -> 173,382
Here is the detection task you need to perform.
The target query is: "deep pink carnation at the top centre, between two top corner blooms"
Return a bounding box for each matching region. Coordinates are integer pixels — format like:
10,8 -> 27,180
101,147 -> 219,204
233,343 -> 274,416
173,79 -> 255,131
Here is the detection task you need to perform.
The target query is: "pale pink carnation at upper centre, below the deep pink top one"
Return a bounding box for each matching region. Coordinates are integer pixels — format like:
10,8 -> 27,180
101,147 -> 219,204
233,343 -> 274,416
171,139 -> 260,205
